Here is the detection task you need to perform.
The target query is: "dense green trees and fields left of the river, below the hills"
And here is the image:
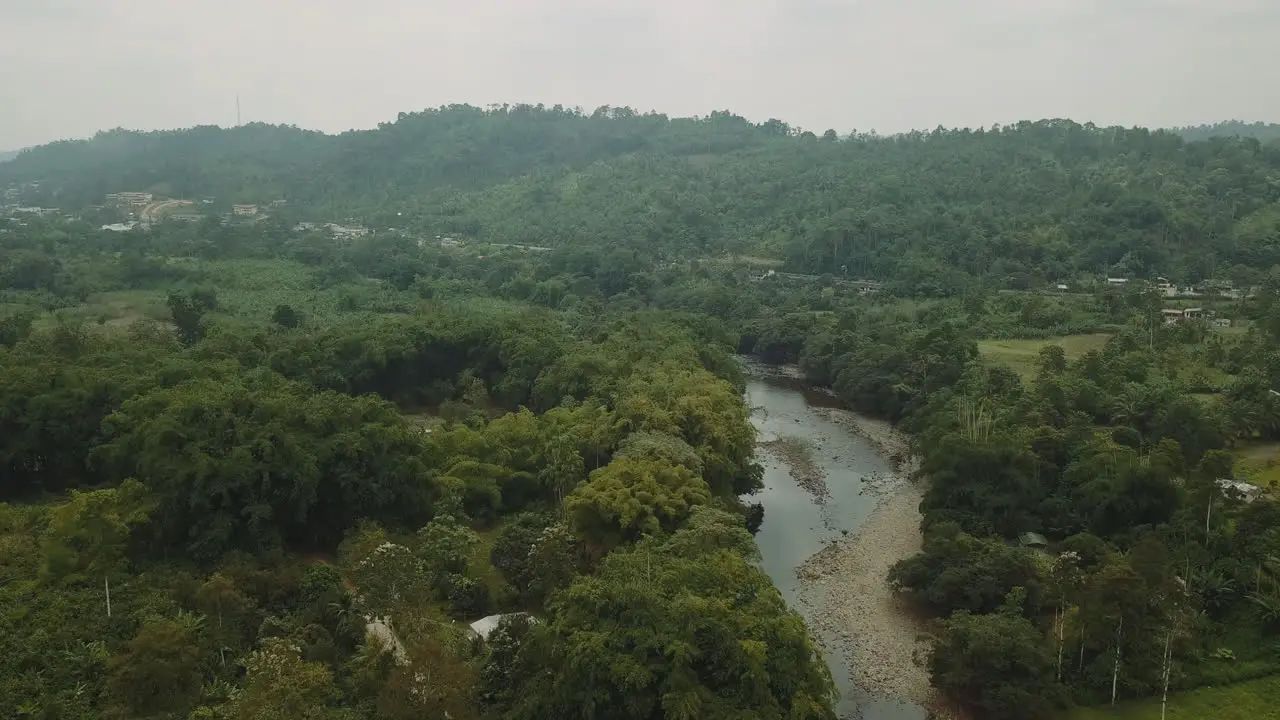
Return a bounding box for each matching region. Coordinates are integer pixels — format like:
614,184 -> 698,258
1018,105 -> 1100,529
0,217 -> 832,719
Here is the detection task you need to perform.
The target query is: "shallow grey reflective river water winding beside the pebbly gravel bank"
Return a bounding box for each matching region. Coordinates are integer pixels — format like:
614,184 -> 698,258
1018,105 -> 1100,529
746,368 -> 925,720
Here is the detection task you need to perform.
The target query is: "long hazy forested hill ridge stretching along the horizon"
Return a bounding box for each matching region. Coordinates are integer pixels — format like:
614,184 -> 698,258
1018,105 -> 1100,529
0,106 -> 1280,284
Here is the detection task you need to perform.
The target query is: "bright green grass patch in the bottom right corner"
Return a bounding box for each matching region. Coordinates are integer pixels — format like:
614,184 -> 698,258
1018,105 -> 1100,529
1062,676 -> 1280,720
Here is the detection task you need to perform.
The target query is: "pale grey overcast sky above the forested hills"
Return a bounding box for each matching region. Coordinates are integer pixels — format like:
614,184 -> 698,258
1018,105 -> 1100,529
0,0 -> 1280,150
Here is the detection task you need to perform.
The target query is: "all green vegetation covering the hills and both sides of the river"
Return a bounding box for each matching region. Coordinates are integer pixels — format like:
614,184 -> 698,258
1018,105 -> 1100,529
0,108 -> 1280,720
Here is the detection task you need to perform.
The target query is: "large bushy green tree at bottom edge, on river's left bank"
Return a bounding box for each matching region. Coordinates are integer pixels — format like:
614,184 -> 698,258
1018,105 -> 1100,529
506,524 -> 833,720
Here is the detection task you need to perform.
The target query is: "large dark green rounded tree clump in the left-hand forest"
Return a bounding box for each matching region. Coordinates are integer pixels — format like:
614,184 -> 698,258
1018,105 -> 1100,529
91,373 -> 433,559
